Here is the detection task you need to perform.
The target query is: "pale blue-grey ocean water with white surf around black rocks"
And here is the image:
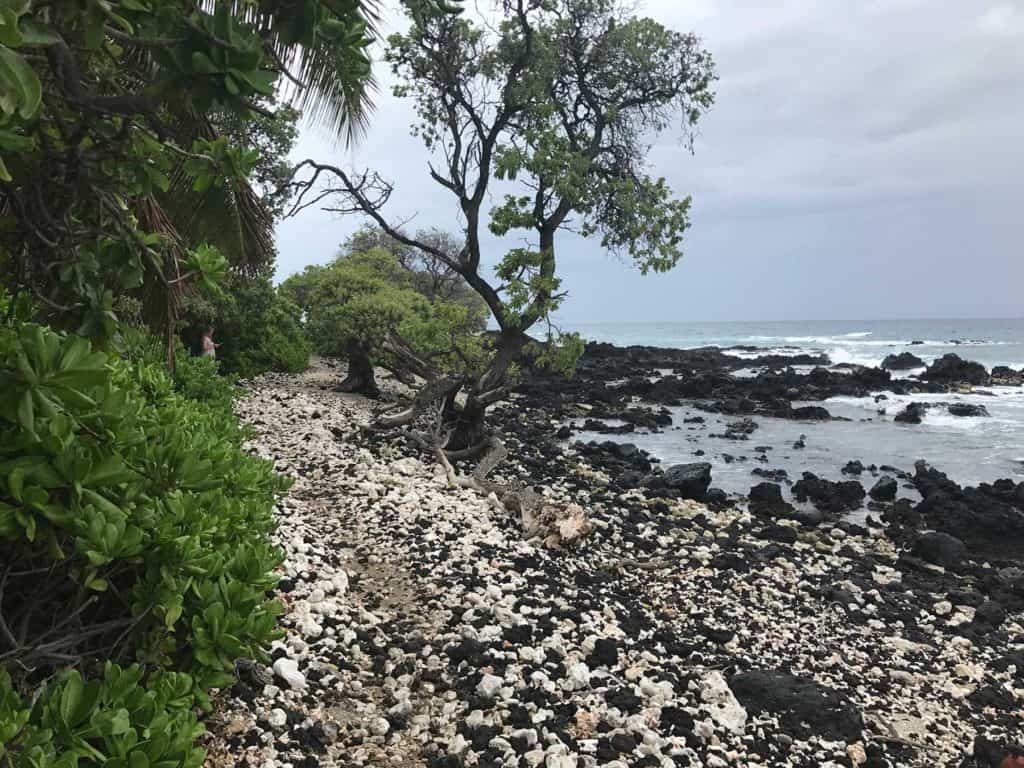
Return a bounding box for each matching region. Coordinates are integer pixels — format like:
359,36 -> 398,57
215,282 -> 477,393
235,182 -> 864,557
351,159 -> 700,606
566,318 -> 1024,505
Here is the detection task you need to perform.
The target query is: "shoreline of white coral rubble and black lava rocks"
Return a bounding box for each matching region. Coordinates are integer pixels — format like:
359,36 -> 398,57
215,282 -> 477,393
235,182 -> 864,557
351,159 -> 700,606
203,358 -> 1024,768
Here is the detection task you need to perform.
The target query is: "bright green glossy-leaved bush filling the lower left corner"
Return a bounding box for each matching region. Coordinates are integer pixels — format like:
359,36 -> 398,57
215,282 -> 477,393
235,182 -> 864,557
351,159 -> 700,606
0,323 -> 287,768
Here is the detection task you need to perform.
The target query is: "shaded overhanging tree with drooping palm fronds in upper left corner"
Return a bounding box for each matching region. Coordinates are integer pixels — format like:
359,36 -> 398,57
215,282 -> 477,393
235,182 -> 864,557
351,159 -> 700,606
0,0 -> 407,362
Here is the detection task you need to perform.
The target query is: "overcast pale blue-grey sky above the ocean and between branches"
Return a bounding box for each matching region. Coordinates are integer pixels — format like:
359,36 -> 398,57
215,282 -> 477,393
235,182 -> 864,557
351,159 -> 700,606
276,0 -> 1024,326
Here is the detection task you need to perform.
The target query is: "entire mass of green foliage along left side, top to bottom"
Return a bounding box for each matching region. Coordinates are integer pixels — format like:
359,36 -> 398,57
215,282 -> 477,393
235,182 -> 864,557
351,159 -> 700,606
0,0 -> 460,768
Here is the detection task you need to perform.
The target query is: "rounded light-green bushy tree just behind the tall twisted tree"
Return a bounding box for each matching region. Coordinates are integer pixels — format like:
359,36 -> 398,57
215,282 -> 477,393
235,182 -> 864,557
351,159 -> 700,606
282,232 -> 484,393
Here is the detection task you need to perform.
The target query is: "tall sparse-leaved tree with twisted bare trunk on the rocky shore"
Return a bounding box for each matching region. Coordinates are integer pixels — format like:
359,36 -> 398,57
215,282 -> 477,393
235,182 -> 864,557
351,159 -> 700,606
292,0 -> 715,460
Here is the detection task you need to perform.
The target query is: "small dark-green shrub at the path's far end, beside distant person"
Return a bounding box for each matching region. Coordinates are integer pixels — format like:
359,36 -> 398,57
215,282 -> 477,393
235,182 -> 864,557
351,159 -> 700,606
178,279 -> 311,378
